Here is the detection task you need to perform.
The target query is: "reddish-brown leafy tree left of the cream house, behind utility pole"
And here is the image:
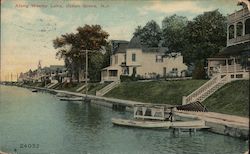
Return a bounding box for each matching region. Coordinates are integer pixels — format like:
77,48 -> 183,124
53,25 -> 109,81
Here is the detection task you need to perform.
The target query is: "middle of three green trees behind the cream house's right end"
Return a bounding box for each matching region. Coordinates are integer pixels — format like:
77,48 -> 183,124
162,14 -> 188,52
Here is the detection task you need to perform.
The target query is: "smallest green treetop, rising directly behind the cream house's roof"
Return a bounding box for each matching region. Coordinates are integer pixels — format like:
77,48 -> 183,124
134,20 -> 161,47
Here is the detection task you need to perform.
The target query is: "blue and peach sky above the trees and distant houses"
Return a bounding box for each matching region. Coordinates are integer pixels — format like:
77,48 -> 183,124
0,0 -> 240,81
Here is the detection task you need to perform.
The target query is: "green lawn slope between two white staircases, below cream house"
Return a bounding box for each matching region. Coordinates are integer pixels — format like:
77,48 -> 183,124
105,80 -> 207,105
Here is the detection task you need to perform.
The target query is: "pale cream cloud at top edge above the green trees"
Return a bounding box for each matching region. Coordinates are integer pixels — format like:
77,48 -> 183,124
138,1 -> 211,15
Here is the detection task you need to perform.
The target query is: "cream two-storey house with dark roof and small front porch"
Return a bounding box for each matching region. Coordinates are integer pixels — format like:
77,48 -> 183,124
102,37 -> 187,81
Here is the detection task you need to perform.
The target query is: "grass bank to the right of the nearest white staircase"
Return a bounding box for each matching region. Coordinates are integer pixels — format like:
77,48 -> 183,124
203,80 -> 249,117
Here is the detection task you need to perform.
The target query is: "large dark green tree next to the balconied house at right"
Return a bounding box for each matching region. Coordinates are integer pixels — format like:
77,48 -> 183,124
184,10 -> 226,63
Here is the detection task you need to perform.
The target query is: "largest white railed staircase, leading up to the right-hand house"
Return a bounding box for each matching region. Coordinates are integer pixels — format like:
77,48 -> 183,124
182,74 -> 231,105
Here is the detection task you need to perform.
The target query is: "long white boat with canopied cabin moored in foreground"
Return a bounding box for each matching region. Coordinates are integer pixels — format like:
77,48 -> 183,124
111,104 -> 208,130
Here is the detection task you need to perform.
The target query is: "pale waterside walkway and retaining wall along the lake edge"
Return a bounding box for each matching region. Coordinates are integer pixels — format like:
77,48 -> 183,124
0,85 -> 249,140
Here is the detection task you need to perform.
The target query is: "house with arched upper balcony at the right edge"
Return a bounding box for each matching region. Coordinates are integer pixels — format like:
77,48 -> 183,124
207,0 -> 250,78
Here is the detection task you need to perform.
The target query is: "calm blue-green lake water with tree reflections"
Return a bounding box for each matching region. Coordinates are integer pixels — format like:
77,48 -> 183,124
0,86 -> 248,154
